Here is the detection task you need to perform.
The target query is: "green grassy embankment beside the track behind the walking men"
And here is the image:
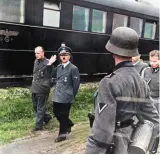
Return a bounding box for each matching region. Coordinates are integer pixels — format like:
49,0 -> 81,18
0,83 -> 97,144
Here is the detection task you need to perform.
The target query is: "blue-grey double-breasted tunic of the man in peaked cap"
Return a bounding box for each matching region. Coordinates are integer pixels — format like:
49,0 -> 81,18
53,62 -> 80,103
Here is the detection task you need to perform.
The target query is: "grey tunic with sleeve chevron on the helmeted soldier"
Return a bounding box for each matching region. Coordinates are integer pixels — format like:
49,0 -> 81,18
86,62 -> 159,154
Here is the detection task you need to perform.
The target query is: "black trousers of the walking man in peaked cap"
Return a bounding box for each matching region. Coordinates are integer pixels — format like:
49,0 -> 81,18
53,102 -> 73,134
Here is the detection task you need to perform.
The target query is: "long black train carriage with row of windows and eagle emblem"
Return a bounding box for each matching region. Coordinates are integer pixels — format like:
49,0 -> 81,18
0,0 -> 159,76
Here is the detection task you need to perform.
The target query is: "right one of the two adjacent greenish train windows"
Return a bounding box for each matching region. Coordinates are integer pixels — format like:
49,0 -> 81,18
92,10 -> 107,33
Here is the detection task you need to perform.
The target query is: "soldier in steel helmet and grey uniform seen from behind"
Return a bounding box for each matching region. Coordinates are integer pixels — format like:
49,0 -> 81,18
86,27 -> 159,154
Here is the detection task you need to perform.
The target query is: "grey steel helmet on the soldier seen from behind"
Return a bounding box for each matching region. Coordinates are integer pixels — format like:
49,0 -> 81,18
106,27 -> 139,57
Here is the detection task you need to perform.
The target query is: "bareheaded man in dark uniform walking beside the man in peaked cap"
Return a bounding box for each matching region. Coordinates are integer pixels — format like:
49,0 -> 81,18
31,46 -> 56,131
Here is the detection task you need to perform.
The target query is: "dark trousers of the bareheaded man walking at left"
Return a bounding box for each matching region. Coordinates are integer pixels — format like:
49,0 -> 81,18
32,93 -> 51,128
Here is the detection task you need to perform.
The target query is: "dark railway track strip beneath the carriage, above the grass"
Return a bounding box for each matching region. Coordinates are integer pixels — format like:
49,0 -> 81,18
0,74 -> 106,88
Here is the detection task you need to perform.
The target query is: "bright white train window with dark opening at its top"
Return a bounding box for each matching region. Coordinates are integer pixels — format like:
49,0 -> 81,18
43,0 -> 60,27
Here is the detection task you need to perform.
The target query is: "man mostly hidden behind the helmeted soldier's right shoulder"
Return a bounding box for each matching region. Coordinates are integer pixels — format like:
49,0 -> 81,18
132,54 -> 148,75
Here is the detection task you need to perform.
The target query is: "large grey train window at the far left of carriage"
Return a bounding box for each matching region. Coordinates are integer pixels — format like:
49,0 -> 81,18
0,0 -> 25,23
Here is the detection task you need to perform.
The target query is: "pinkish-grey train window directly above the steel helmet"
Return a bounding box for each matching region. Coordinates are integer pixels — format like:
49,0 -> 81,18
112,14 -> 128,30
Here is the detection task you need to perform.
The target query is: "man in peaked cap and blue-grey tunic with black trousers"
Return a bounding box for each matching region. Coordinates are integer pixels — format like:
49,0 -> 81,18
49,43 -> 80,142
